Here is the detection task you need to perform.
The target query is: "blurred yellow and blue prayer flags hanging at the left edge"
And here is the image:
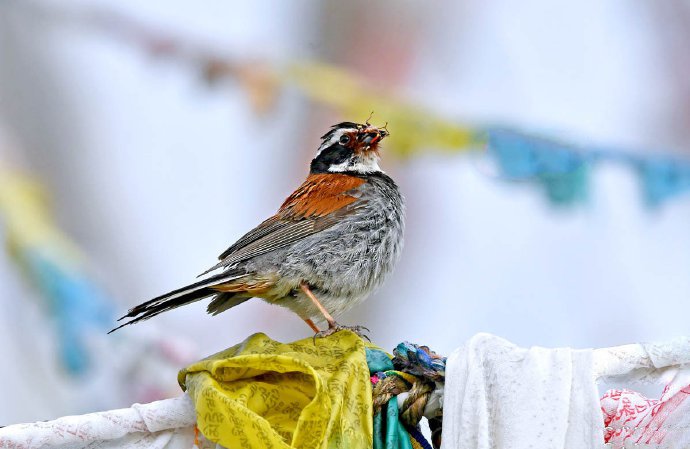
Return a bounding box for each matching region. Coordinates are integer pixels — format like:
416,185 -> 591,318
0,170 -> 114,374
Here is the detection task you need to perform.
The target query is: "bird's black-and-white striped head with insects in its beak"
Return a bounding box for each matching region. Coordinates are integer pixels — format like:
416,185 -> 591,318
311,122 -> 389,174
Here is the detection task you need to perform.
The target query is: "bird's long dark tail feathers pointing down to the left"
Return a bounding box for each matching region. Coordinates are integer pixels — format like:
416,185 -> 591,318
108,270 -> 246,334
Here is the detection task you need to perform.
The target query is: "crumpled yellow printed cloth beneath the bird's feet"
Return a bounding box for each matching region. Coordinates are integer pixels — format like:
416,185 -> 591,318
179,331 -> 373,449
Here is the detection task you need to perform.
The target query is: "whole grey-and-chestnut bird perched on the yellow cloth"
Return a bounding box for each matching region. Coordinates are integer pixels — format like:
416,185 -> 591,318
111,121 -> 404,336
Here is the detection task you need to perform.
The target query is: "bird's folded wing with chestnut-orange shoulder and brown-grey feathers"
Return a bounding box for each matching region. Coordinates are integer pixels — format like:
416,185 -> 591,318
202,173 -> 366,275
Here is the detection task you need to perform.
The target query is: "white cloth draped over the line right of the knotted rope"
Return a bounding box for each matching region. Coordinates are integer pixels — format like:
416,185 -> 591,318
443,334 -> 690,449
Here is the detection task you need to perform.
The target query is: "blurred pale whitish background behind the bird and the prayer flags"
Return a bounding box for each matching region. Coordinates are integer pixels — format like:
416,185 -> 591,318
0,0 -> 690,424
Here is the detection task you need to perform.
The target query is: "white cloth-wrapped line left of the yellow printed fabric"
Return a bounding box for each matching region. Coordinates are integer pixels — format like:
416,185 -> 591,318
0,395 -> 196,449
